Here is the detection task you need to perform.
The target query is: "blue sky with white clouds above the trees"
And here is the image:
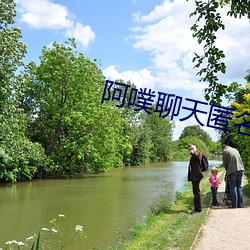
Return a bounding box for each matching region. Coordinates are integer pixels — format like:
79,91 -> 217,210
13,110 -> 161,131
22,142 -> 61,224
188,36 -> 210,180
15,0 -> 250,140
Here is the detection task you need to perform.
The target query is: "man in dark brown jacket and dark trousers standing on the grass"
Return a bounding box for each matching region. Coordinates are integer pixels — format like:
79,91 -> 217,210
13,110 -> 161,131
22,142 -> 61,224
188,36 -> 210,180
188,143 -> 203,214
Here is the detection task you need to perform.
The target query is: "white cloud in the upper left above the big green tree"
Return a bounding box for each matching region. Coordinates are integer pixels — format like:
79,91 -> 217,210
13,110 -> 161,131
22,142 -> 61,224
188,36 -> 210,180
16,0 -> 95,48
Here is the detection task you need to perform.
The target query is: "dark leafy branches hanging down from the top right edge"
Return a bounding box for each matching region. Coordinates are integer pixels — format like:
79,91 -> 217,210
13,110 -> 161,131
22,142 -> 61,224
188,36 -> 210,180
190,0 -> 250,104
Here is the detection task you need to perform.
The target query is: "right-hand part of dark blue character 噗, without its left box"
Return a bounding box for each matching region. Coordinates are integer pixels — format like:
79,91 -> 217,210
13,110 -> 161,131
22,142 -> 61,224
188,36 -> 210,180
134,88 -> 155,114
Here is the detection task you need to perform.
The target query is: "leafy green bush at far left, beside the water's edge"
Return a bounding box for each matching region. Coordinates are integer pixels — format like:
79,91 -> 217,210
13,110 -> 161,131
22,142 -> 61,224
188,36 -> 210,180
0,109 -> 50,182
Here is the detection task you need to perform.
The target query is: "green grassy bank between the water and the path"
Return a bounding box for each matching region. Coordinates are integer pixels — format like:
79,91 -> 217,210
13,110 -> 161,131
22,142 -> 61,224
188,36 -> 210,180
111,170 -> 223,250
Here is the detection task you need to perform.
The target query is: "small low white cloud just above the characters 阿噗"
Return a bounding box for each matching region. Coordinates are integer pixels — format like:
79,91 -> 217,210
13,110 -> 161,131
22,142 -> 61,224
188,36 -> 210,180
103,65 -> 154,90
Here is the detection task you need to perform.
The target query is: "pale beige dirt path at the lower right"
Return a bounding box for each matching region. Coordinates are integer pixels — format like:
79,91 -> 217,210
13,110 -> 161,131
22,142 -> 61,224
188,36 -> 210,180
191,174 -> 250,250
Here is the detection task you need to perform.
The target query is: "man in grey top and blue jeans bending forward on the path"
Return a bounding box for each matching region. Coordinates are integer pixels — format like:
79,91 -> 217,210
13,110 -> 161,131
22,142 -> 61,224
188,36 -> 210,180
222,145 -> 244,208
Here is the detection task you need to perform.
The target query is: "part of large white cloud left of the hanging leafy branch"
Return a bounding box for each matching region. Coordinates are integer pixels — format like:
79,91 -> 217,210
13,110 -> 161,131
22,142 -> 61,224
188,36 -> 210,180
132,0 -> 199,92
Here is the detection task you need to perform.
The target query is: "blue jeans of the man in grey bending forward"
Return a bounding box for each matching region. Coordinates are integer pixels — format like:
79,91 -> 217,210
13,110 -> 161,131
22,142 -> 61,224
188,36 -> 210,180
228,170 -> 244,208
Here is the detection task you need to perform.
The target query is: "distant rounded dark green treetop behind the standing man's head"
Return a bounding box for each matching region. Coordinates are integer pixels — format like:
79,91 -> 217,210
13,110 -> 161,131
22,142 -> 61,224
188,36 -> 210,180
179,125 -> 212,147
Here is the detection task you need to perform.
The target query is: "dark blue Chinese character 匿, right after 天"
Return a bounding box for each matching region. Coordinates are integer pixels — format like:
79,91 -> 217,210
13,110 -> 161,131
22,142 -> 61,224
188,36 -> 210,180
207,104 -> 234,131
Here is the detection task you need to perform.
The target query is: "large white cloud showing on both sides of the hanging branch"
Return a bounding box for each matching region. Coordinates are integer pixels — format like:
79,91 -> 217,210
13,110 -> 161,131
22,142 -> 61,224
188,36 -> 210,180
132,0 -> 250,93
